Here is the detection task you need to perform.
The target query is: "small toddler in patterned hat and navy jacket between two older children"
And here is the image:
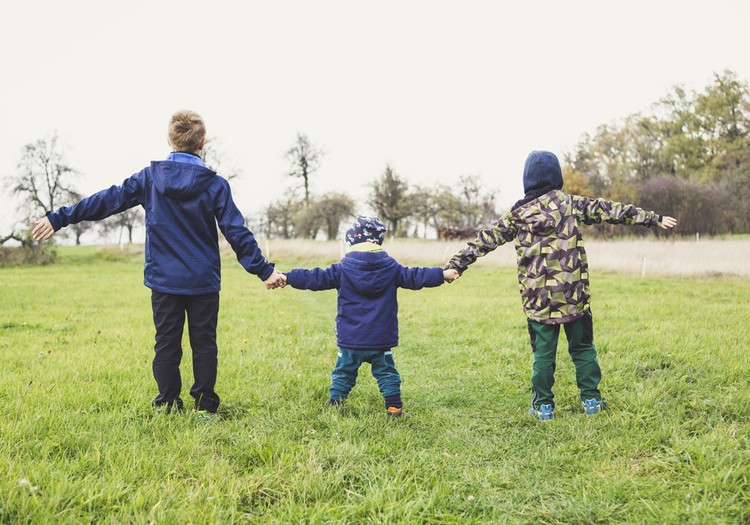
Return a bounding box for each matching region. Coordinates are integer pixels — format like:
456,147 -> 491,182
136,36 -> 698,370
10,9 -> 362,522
282,215 -> 458,416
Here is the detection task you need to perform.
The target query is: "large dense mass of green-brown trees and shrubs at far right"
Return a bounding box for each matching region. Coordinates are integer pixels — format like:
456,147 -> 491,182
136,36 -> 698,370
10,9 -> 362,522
564,71 -> 750,235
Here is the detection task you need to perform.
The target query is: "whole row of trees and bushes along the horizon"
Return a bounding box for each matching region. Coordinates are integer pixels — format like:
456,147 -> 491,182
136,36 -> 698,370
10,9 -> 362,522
0,71 -> 750,245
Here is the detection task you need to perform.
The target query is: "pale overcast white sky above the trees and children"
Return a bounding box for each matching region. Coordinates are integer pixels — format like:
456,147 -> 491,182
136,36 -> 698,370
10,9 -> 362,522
0,0 -> 750,233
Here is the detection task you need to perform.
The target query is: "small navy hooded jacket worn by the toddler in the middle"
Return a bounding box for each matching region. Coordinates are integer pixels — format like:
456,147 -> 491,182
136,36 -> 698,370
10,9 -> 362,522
287,251 -> 443,350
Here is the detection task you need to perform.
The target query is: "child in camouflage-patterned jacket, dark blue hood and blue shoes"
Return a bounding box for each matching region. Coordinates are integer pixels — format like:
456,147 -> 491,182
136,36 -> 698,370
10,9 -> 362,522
446,151 -> 676,420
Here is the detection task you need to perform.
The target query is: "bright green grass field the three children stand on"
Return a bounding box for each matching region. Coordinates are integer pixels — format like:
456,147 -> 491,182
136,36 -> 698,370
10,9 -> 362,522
0,244 -> 750,524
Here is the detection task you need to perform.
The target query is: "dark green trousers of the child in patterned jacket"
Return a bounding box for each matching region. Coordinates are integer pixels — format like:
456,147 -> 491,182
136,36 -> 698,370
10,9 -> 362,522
528,311 -> 602,408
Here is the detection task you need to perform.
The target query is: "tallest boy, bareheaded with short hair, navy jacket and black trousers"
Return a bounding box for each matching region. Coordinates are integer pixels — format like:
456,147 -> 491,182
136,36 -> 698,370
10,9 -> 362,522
33,110 -> 283,418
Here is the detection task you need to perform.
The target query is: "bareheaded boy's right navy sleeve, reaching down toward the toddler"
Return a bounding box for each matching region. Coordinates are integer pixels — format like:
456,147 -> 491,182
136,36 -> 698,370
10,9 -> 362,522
214,178 -> 273,281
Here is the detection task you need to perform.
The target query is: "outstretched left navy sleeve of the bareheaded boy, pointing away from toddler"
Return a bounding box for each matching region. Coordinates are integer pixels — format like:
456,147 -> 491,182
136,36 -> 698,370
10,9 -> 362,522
47,171 -> 144,231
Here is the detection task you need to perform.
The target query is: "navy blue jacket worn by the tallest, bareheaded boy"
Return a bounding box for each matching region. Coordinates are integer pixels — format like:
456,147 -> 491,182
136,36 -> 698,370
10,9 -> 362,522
47,153 -> 273,295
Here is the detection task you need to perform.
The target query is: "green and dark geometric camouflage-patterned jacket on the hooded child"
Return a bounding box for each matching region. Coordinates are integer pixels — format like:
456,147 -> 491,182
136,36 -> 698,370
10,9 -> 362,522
446,190 -> 661,324
